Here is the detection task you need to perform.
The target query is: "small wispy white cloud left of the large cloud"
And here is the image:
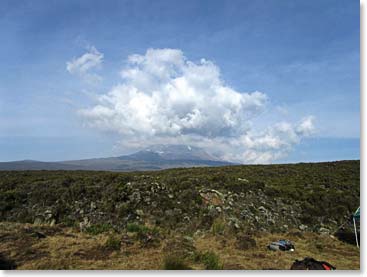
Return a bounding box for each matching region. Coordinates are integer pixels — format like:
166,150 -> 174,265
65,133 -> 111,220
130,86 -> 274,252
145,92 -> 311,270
66,46 -> 104,83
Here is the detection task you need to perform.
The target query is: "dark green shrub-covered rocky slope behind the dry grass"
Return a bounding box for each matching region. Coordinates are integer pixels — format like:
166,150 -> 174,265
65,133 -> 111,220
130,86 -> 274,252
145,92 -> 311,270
0,161 -> 360,268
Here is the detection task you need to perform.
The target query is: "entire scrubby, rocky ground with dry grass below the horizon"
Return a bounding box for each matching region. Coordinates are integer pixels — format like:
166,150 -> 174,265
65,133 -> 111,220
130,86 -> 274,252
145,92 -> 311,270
0,161 -> 359,269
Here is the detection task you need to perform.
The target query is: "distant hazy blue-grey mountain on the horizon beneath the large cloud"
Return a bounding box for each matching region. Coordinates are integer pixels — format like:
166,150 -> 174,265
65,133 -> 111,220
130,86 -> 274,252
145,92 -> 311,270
0,145 -> 232,171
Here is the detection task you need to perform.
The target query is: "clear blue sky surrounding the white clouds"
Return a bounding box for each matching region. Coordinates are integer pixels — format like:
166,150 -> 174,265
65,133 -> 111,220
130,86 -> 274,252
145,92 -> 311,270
0,0 -> 360,162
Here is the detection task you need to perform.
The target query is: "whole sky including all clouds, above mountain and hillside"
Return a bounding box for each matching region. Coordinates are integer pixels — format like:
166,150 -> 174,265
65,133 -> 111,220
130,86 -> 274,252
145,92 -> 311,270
0,0 -> 360,163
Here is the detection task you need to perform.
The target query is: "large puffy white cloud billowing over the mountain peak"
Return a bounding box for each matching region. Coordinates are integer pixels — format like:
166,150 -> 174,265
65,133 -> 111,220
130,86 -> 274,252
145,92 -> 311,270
76,49 -> 314,163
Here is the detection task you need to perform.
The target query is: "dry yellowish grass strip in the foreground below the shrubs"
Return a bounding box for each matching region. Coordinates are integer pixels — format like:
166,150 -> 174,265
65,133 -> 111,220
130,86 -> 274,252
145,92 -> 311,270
0,222 -> 360,270
